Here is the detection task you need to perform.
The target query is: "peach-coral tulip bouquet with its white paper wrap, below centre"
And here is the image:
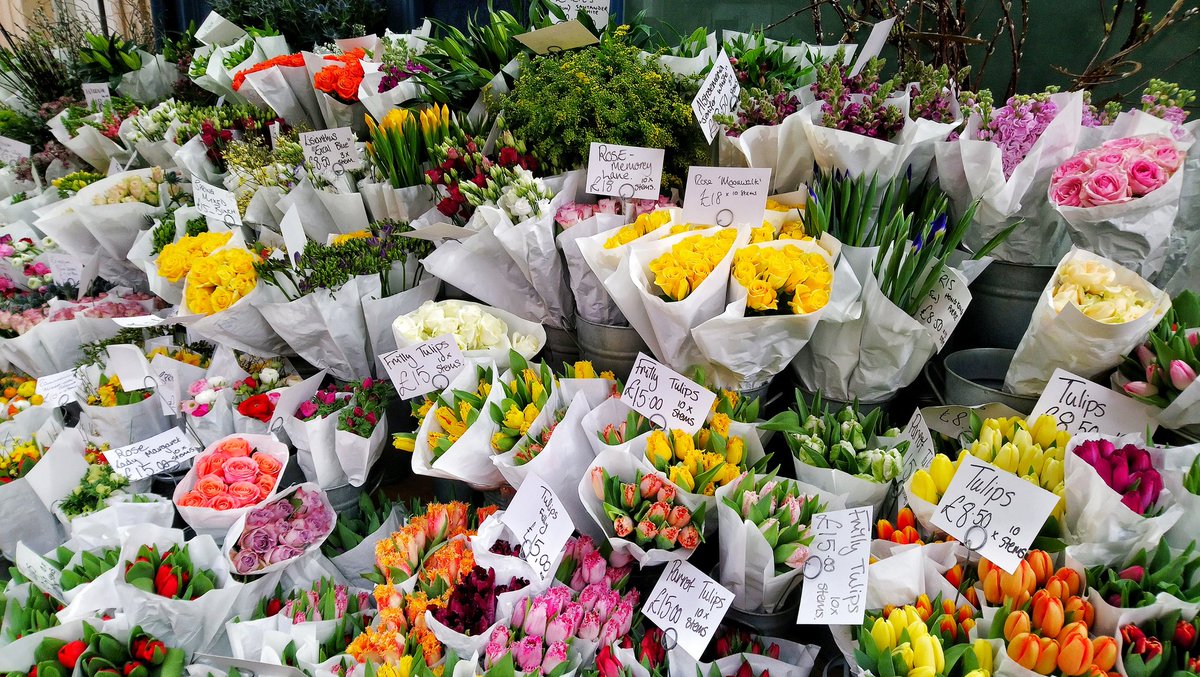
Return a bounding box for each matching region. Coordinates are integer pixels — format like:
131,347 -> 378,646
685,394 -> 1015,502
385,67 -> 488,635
578,450 -> 706,567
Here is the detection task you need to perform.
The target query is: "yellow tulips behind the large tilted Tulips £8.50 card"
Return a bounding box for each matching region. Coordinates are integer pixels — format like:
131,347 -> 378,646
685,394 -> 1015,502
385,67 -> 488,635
912,415 -> 1070,520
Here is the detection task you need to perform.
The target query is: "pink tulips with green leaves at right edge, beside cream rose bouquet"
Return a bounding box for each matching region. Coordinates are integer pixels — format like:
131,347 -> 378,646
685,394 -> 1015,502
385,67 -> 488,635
1121,289 -> 1200,408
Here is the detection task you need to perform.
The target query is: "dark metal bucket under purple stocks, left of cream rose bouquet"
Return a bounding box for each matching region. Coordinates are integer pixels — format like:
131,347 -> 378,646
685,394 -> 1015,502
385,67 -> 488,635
956,260 -> 1055,348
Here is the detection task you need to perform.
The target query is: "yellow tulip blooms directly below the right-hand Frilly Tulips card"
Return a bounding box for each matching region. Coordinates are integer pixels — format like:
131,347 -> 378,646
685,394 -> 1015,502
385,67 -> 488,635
646,414 -> 746,496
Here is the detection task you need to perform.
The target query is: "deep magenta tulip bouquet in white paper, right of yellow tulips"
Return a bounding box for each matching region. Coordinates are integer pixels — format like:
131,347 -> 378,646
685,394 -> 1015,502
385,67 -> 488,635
1066,433 -> 1183,563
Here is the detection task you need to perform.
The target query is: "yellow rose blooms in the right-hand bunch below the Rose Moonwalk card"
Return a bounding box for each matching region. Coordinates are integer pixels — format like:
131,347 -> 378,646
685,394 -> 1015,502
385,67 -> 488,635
733,245 -> 833,314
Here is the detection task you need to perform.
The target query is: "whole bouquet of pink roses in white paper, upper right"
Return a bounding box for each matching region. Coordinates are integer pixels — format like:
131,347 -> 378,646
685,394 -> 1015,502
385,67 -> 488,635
1050,132 -> 1184,277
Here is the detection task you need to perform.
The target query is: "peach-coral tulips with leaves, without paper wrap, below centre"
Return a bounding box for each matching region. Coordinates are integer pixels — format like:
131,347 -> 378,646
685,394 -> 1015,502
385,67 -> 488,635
592,467 -> 707,550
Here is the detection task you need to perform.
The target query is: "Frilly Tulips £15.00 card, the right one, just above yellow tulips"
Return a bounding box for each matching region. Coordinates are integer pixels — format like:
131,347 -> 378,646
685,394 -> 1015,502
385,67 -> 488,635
620,353 -> 716,435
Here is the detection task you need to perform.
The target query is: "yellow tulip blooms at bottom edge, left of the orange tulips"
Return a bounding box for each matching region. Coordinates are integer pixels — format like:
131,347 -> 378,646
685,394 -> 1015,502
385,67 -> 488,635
854,605 -> 992,677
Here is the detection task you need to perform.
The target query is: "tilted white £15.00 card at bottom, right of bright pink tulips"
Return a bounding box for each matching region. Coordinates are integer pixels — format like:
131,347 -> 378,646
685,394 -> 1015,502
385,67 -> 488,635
642,559 -> 733,660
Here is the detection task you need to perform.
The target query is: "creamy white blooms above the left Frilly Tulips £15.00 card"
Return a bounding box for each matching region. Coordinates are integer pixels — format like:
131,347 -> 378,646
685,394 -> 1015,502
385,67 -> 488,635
391,300 -> 546,366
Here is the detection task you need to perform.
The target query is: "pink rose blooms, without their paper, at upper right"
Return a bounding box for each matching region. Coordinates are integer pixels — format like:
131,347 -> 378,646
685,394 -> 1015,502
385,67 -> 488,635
1050,136 -> 1183,208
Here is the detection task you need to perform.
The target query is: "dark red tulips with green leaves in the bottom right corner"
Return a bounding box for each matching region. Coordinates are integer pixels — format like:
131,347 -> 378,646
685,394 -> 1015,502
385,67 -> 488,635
1121,611 -> 1200,677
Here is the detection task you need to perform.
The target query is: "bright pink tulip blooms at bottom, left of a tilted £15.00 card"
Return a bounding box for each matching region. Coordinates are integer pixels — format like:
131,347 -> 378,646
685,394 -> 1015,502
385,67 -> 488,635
484,580 -> 638,675
